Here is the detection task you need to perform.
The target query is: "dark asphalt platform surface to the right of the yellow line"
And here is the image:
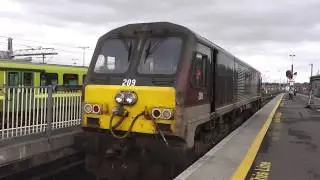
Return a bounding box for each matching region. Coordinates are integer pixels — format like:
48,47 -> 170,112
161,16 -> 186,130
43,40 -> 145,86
246,95 -> 320,180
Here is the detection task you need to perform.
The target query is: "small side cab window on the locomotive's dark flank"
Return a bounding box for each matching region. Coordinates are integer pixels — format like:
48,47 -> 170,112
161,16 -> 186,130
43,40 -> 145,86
192,53 -> 208,88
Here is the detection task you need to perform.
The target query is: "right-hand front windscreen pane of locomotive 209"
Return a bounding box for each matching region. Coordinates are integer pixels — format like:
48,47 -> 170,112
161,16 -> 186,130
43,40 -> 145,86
138,37 -> 182,74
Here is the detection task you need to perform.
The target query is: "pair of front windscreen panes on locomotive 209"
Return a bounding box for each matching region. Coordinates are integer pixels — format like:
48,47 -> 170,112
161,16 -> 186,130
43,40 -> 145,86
94,37 -> 182,74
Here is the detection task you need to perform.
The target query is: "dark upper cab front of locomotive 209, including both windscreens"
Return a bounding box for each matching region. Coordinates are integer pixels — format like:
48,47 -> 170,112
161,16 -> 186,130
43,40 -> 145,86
87,25 -> 188,87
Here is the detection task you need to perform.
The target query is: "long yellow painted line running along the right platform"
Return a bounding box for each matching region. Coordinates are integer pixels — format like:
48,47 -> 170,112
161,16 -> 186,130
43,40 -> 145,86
231,94 -> 283,180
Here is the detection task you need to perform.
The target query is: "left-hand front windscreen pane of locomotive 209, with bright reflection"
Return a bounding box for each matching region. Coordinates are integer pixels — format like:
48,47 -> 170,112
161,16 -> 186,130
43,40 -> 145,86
94,39 -> 134,73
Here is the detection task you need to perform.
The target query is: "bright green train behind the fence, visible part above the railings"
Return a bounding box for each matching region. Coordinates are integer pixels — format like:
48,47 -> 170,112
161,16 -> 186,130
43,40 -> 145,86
0,59 -> 87,87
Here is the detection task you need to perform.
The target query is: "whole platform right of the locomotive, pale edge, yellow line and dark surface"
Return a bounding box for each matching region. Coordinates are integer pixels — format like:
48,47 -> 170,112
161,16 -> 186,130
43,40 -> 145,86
175,94 -> 320,180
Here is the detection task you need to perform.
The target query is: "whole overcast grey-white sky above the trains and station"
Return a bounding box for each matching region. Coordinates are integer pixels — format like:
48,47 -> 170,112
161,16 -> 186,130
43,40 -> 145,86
0,0 -> 320,82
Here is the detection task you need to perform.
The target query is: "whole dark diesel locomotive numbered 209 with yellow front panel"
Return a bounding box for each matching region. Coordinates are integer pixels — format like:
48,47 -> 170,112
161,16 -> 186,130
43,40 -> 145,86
76,22 -> 261,178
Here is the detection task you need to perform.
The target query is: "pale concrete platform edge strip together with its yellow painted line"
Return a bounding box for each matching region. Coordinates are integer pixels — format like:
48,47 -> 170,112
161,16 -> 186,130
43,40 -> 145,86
175,94 -> 282,180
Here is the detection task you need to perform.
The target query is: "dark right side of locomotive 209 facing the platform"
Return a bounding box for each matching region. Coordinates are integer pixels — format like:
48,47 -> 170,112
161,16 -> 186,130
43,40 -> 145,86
176,35 -> 261,148
